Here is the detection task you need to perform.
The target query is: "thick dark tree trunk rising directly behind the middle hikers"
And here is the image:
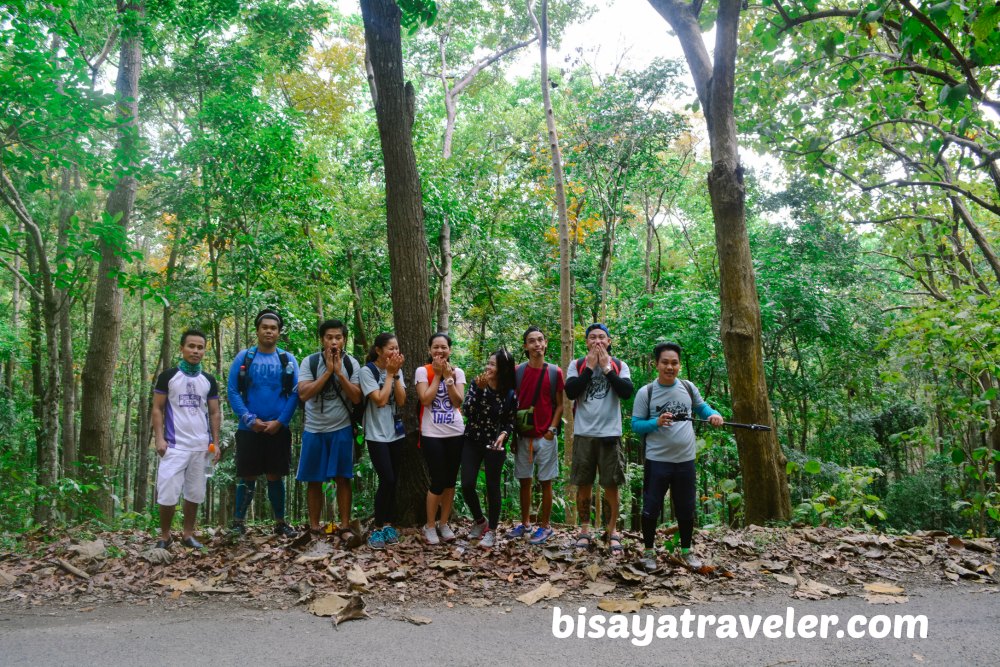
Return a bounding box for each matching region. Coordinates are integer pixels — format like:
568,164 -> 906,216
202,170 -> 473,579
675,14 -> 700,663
361,0 -> 431,525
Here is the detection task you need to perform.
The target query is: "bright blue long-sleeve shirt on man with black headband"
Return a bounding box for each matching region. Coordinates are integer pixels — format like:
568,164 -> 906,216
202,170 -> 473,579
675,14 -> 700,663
227,349 -> 299,431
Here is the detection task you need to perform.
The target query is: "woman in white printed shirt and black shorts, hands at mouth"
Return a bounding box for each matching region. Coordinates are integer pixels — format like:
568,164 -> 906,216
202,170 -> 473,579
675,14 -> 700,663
413,332 -> 465,544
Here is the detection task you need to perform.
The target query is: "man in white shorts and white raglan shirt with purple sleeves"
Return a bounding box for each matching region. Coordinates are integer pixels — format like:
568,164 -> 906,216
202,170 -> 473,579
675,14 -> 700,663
152,329 -> 221,549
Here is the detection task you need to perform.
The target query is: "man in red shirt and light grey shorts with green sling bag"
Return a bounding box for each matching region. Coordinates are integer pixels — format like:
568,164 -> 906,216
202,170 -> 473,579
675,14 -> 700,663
507,326 -> 563,544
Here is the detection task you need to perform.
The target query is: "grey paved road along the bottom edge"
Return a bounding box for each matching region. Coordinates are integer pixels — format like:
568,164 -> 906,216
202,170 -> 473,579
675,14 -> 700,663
0,584 -> 1000,667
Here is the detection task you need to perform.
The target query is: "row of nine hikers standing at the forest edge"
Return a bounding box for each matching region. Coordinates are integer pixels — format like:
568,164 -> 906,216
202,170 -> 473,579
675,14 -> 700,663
152,309 -> 723,571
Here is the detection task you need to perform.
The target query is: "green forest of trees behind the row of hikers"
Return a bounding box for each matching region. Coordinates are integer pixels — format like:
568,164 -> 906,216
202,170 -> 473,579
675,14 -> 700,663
0,0 -> 1000,549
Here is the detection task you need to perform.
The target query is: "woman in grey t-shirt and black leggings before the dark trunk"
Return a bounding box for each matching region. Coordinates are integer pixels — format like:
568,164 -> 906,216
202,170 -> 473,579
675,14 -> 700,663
359,333 -> 406,549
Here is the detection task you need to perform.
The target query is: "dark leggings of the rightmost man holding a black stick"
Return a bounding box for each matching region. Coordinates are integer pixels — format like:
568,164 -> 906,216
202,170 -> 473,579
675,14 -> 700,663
642,459 -> 698,549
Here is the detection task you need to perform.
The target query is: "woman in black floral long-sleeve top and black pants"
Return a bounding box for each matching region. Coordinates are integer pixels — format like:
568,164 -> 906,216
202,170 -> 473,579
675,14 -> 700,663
462,348 -> 517,548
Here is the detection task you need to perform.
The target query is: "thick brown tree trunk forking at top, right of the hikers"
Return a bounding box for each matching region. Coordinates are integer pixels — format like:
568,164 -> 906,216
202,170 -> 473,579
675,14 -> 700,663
650,0 -> 791,524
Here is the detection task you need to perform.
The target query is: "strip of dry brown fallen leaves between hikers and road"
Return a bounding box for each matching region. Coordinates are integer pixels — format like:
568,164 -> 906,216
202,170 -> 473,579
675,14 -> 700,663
0,526 -> 1000,623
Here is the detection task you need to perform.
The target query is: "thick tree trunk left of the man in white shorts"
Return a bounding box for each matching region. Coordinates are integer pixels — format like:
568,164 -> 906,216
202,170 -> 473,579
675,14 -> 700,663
80,1 -> 144,519
